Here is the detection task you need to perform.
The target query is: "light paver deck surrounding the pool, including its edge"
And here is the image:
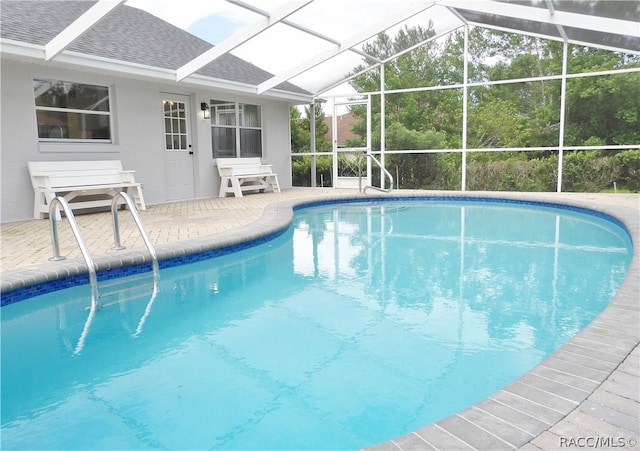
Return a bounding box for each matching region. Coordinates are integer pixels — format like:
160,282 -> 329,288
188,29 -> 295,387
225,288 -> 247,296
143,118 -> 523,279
0,188 -> 640,450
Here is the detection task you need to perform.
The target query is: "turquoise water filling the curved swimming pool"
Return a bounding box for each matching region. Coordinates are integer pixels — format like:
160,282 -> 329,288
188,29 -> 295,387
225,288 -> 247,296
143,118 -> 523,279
3,202 -> 630,448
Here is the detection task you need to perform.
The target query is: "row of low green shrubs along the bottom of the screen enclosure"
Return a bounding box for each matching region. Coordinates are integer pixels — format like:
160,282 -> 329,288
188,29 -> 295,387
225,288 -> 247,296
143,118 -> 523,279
292,150 -> 640,193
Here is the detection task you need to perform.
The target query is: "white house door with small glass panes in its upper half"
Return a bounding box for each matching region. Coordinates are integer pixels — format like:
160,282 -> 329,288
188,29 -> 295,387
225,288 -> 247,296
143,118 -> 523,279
162,95 -> 195,200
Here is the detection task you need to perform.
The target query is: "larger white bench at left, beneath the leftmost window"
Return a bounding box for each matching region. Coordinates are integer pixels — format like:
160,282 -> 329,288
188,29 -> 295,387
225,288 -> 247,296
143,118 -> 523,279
28,160 -> 146,219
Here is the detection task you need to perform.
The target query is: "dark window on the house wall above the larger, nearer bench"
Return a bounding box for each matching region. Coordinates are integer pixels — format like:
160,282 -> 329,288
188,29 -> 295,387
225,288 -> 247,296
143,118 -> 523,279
33,79 -> 111,142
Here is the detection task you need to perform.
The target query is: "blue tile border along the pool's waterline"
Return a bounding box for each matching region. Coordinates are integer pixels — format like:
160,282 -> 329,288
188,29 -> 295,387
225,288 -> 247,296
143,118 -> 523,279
0,195 -> 634,307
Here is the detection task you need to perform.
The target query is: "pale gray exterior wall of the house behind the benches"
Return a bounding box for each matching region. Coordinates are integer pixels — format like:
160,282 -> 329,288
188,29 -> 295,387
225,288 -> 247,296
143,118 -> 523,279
0,56 -> 291,222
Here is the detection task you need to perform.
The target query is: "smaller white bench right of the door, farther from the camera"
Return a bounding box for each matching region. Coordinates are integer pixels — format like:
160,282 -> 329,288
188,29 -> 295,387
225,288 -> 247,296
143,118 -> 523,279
216,158 -> 280,197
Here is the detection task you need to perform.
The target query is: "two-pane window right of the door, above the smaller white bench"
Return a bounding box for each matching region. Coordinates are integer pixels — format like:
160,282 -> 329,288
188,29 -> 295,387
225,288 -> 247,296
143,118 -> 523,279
210,100 -> 262,158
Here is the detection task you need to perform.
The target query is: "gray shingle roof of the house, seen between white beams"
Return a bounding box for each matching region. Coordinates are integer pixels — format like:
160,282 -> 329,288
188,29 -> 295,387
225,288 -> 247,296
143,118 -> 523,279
0,0 -> 309,94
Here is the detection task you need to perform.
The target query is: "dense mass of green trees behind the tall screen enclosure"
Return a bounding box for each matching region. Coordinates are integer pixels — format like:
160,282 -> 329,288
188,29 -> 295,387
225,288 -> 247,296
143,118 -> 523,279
344,24 -> 640,191
